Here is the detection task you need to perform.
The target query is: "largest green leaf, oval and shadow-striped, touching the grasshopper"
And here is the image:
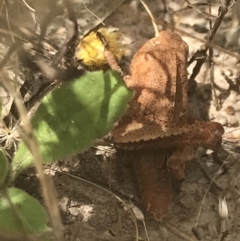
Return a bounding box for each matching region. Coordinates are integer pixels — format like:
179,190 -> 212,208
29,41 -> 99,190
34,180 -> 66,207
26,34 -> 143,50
12,71 -> 133,178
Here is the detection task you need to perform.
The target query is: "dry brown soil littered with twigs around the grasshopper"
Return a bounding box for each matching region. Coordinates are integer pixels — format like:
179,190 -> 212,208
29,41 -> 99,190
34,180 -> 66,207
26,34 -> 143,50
1,0 -> 240,241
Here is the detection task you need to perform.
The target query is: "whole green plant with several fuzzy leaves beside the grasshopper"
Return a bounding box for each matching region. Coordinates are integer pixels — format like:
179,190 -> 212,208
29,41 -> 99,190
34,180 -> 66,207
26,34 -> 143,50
0,71 -> 132,238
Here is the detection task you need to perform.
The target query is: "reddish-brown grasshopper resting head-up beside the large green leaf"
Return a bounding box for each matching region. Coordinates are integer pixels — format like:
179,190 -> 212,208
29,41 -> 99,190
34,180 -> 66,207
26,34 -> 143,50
97,31 -> 224,220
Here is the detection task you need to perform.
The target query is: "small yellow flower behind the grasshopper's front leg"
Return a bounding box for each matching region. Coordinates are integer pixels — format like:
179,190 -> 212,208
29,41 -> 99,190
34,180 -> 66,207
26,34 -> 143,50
75,28 -> 125,68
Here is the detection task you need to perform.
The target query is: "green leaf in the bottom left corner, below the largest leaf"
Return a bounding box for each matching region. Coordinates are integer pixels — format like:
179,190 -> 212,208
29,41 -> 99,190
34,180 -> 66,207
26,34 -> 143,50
0,188 -> 50,238
